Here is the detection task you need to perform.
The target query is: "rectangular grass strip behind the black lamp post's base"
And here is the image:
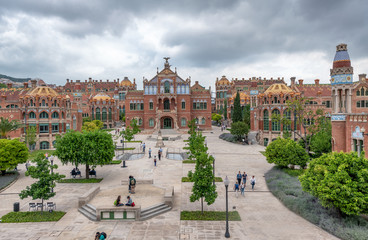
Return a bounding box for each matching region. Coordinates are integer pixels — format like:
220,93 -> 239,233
180,211 -> 241,221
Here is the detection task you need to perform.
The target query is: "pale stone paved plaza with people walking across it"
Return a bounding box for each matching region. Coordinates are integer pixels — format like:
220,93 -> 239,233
0,127 -> 337,240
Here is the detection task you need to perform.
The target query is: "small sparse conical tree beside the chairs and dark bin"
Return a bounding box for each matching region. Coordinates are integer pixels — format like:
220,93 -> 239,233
19,153 -> 65,211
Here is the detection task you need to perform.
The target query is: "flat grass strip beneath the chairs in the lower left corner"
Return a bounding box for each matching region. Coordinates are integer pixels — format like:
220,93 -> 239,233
1,211 -> 65,223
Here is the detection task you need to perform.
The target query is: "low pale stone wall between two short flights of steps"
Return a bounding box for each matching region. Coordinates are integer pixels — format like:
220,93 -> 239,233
96,206 -> 141,221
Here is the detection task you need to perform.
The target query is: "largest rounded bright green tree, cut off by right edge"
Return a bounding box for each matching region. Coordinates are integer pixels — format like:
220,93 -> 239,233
299,152 -> 368,215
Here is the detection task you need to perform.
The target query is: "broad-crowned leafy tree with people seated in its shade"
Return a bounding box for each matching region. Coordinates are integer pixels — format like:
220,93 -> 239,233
55,131 -> 114,178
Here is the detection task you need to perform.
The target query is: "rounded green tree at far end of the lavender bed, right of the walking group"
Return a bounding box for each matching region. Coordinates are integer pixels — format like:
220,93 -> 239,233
265,138 -> 309,167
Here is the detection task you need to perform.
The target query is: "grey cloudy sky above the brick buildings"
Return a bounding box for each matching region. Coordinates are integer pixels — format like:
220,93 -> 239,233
0,0 -> 368,89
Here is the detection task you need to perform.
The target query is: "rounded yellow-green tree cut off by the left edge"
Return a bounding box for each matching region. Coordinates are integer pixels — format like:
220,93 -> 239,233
0,139 -> 28,175
